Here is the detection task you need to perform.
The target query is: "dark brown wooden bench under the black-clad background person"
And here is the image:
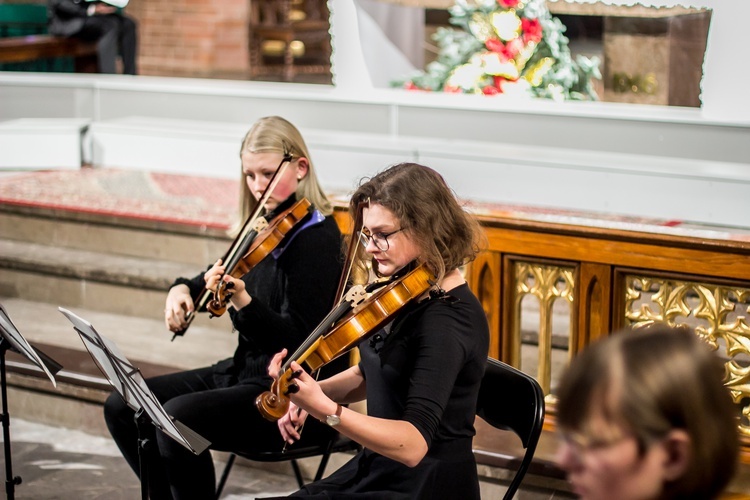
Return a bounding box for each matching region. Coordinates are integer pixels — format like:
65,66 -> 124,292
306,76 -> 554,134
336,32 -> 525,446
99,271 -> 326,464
0,35 -> 98,73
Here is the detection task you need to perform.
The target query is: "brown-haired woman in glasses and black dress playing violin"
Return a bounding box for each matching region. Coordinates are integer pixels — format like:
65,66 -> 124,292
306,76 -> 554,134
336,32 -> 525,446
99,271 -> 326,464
269,163 -> 489,500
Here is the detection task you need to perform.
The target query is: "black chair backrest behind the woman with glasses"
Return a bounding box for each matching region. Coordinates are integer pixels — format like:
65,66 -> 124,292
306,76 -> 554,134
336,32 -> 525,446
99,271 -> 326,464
477,358 -> 544,500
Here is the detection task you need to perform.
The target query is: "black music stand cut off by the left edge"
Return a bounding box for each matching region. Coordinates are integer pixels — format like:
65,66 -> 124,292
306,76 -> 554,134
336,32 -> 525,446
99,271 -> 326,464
0,304 -> 62,500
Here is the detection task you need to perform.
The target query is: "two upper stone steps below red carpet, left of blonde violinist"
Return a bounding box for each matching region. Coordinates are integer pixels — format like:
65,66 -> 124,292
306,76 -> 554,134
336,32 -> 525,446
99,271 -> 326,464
0,186 -> 231,320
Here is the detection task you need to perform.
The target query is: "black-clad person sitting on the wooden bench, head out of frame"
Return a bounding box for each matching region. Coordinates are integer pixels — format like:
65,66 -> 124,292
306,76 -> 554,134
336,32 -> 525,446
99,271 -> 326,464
47,0 -> 138,75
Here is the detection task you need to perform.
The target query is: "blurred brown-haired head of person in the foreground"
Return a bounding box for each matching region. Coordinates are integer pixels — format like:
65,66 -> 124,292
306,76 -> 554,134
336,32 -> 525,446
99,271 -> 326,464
557,325 -> 738,500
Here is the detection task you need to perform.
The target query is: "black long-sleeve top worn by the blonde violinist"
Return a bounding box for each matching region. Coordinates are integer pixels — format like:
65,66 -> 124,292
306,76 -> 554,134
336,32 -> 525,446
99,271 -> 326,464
172,196 -> 345,387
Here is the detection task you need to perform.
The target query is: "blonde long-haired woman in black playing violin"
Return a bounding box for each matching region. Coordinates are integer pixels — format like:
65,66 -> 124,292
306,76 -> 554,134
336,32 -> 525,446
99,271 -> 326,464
104,116 -> 348,499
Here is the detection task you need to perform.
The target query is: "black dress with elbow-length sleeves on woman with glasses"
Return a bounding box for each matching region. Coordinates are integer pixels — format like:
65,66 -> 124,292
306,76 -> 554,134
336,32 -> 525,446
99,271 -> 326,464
284,284 -> 489,500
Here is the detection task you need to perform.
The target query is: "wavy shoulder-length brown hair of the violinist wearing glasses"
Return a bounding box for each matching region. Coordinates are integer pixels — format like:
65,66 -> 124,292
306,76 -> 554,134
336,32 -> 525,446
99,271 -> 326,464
349,163 -> 485,281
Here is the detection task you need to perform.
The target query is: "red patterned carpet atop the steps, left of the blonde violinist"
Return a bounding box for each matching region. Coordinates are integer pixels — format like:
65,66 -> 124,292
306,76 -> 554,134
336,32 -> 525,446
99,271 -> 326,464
0,168 -> 239,229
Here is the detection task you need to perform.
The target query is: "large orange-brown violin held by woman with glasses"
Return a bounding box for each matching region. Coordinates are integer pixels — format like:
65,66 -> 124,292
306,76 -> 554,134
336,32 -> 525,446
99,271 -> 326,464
255,264 -> 435,422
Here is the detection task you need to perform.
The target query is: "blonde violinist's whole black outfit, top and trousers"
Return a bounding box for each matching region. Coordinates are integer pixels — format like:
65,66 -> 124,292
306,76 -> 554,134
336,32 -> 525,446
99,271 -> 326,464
104,197 -> 348,499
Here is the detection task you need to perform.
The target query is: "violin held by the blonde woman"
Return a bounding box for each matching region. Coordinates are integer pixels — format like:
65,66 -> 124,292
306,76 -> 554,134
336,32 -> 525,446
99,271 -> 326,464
206,198 -> 312,317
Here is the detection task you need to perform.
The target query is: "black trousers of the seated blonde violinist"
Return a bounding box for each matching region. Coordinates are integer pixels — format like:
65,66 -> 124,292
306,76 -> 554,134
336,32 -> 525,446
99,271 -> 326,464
104,367 -> 335,500
